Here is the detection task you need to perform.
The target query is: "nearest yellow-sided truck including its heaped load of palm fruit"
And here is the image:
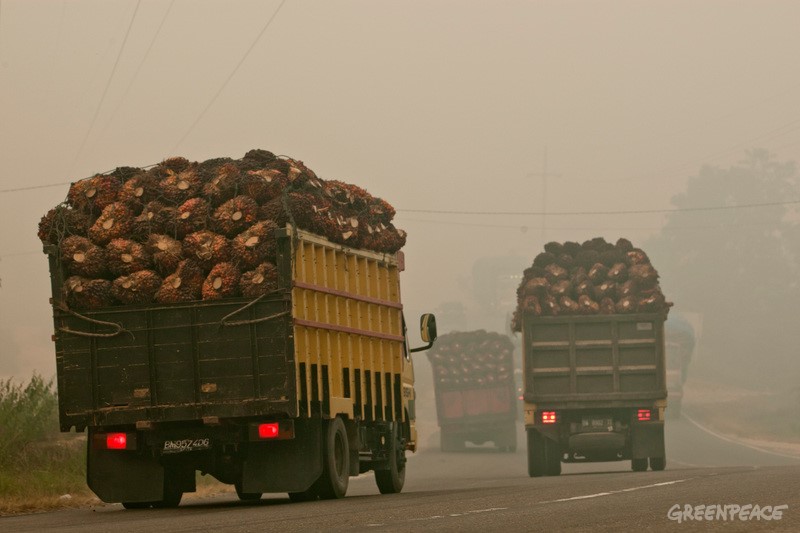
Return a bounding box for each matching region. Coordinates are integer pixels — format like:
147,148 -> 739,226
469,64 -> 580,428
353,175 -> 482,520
39,150 -> 436,508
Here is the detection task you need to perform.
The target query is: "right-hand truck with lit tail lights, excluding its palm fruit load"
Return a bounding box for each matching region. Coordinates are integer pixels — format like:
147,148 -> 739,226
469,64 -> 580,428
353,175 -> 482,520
521,312 -> 667,477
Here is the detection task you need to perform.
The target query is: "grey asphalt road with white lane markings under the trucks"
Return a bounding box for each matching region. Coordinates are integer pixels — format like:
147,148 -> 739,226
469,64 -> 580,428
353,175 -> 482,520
0,419 -> 800,533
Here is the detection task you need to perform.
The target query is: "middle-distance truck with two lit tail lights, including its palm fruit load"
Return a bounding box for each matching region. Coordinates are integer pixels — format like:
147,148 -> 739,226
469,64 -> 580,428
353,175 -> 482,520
512,238 -> 672,477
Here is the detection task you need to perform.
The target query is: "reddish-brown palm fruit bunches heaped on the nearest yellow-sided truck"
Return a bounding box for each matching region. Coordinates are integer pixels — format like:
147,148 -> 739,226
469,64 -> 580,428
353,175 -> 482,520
38,149 -> 406,309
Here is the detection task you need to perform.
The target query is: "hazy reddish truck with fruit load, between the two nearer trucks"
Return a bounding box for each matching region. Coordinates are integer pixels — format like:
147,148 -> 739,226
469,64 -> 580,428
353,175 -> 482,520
428,330 -> 518,452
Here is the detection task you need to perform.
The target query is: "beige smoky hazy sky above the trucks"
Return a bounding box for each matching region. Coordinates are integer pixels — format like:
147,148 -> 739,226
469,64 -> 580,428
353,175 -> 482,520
0,0 -> 800,377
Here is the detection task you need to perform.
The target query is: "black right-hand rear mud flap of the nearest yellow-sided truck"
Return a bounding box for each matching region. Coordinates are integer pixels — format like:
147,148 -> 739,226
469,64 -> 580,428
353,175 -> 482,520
242,419 -> 322,493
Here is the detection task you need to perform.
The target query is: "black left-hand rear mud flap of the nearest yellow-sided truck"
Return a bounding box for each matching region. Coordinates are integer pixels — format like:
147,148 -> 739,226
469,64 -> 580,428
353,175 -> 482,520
86,428 -> 164,503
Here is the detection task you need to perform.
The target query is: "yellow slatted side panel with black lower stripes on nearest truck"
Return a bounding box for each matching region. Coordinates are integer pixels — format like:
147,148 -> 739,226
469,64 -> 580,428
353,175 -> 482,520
291,231 -> 406,421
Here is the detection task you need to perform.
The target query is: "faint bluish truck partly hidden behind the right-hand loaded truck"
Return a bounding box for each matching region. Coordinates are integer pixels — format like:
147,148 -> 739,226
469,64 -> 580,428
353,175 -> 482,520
666,312 -> 696,419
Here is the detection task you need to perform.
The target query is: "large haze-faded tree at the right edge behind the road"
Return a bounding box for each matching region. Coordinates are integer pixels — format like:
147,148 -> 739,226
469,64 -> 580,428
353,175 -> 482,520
647,150 -> 800,388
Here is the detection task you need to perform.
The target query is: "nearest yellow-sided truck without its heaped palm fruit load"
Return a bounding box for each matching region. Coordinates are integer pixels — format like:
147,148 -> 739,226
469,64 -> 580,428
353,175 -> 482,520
45,225 -> 436,509
